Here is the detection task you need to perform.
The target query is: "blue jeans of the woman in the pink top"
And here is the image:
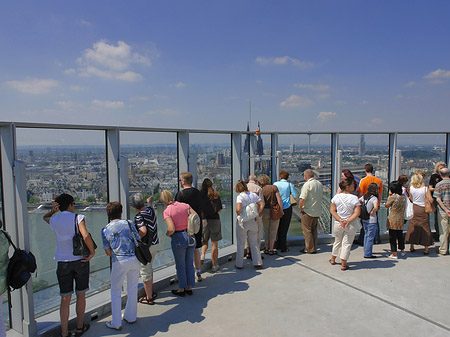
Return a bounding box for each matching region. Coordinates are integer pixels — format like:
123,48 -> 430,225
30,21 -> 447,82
171,232 -> 195,289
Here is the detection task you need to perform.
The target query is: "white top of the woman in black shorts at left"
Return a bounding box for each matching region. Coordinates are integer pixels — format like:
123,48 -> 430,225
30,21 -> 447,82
50,211 -> 85,262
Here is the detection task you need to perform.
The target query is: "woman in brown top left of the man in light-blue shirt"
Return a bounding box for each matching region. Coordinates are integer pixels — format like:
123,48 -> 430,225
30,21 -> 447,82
258,174 -> 283,255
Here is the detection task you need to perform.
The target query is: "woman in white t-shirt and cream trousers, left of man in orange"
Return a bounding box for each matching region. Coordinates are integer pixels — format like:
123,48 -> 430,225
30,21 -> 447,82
329,179 -> 361,271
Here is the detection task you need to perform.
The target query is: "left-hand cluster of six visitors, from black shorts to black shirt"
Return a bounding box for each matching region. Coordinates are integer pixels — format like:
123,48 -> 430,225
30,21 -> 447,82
39,172 -> 222,337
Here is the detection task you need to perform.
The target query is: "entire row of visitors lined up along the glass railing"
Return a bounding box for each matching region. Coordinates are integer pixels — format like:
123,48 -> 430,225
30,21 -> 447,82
0,162 -> 450,337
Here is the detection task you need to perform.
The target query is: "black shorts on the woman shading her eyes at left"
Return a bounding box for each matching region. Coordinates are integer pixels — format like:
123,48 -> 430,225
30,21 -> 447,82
56,260 -> 89,296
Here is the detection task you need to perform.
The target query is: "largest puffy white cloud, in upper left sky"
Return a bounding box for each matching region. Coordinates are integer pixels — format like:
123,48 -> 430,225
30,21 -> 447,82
77,40 -> 151,82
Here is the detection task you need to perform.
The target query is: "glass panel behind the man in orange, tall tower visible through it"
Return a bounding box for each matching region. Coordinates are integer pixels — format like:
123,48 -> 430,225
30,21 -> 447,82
339,134 -> 389,232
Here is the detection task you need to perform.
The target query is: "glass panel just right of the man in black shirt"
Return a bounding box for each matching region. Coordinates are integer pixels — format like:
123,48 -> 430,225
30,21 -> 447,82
189,133 -> 233,248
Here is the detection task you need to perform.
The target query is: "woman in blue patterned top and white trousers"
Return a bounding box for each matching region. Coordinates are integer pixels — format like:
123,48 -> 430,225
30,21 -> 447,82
102,201 -> 141,330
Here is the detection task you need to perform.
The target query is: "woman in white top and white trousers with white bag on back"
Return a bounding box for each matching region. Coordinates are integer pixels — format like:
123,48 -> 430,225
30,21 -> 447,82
235,180 -> 264,269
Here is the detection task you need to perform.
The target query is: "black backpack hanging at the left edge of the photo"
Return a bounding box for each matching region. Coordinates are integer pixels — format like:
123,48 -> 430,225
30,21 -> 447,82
2,231 -> 37,289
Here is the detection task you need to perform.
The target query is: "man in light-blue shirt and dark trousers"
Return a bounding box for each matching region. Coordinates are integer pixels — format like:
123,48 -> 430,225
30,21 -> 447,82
274,171 -> 298,253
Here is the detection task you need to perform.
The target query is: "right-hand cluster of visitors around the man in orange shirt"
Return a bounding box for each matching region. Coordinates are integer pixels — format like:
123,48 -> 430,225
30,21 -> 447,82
329,162 -> 450,270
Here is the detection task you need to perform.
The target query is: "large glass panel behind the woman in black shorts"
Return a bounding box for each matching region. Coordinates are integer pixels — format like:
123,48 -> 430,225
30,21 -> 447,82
17,128 -> 109,317
